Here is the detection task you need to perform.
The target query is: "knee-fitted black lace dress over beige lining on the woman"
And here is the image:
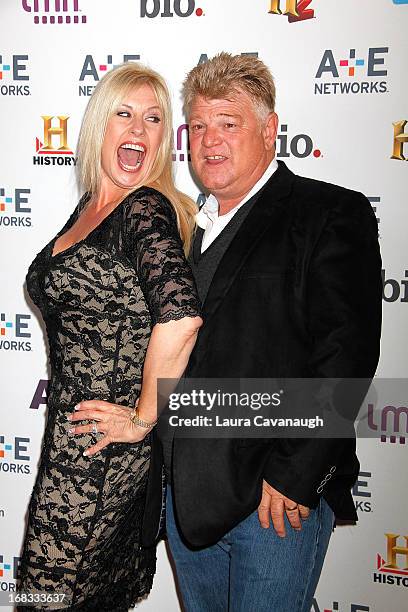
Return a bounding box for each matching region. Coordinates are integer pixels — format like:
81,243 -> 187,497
18,187 -> 200,612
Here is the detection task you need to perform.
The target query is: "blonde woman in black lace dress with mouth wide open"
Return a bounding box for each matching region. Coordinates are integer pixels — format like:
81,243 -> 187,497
18,63 -> 202,612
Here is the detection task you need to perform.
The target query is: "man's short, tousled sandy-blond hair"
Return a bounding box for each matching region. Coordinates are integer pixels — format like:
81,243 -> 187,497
183,52 -> 275,119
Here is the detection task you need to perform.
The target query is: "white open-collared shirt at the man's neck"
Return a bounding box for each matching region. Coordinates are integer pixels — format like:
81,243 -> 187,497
196,158 -> 278,253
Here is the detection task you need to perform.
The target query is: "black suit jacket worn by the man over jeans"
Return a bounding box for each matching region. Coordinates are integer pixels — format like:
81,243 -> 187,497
141,162 -> 382,547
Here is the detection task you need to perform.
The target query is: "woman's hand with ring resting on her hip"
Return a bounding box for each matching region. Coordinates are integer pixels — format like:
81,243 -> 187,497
68,400 -> 150,456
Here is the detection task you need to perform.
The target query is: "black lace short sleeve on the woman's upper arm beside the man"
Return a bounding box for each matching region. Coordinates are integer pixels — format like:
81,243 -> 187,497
125,187 -> 201,325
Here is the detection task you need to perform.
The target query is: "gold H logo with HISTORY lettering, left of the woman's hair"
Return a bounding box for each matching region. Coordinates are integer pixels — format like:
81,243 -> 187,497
33,115 -> 76,166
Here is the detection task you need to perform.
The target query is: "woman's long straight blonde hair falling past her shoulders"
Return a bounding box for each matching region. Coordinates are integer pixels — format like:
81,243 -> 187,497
78,62 -> 197,253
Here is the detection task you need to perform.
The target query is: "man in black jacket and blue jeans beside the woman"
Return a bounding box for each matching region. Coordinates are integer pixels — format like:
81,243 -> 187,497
163,53 -> 381,612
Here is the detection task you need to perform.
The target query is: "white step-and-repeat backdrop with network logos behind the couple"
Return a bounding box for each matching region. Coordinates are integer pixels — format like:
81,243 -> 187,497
0,0 -> 408,612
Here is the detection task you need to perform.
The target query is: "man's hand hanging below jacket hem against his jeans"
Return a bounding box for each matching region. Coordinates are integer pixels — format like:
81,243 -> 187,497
258,480 -> 310,538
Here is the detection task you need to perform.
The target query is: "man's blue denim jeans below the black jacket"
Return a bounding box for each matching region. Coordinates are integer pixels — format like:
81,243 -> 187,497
166,487 -> 334,612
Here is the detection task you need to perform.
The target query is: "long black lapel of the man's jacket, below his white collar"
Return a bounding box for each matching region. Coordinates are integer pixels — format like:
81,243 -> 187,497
200,162 -> 295,321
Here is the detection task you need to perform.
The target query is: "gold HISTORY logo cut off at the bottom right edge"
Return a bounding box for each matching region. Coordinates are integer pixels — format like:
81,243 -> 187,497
373,533 -> 408,587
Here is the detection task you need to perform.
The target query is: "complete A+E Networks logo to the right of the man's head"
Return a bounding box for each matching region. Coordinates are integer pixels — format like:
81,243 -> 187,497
314,47 -> 389,95
